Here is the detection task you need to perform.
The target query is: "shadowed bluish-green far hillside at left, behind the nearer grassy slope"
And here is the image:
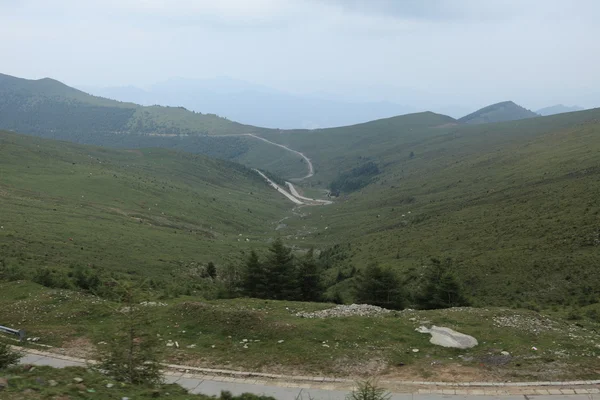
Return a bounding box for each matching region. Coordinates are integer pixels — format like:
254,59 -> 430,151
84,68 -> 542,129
0,74 -> 305,177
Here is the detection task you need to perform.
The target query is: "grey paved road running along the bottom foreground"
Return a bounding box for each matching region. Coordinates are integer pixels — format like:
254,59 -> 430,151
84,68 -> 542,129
16,354 -> 600,400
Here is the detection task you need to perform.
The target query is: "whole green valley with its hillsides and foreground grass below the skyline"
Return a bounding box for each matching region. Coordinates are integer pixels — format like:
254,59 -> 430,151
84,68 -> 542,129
0,72 -> 600,388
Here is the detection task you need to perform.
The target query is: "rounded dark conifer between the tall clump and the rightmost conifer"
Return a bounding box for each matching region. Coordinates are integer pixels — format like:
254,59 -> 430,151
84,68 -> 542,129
356,263 -> 405,310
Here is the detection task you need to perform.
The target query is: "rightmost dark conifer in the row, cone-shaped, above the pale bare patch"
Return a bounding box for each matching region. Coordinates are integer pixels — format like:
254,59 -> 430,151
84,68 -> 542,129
417,258 -> 469,309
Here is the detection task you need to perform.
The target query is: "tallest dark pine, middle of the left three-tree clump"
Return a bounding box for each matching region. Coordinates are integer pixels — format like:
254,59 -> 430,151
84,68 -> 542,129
264,238 -> 299,300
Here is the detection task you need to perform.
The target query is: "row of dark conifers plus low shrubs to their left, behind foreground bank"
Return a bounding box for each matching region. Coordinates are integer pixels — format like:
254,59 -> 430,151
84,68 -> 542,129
12,239 -> 469,310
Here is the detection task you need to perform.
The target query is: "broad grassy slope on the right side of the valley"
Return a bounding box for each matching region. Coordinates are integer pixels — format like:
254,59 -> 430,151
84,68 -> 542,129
287,109 -> 600,304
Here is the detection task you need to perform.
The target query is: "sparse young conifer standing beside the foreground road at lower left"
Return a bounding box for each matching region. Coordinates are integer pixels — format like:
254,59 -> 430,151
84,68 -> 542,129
96,285 -> 161,385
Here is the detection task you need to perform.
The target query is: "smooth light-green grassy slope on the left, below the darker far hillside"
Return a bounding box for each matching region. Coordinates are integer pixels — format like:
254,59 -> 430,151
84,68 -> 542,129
0,132 -> 290,275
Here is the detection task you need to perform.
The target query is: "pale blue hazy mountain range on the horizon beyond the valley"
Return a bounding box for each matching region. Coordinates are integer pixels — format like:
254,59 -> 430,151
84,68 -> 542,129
80,78 -> 418,129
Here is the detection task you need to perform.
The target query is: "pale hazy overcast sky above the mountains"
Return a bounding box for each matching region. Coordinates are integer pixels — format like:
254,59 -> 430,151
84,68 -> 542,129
0,0 -> 600,109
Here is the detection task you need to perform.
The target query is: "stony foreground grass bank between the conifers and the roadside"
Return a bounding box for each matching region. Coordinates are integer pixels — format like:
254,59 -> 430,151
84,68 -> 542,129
0,282 -> 600,380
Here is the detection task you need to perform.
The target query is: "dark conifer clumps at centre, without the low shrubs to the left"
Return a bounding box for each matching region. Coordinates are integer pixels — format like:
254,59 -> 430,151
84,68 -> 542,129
241,239 -> 469,310
